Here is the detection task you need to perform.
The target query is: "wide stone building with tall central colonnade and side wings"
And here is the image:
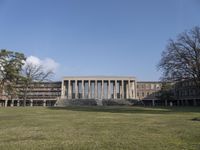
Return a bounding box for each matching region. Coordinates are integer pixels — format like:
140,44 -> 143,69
0,76 -> 200,106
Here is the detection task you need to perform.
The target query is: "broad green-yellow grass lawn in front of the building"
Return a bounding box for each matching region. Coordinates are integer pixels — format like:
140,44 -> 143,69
0,107 -> 200,150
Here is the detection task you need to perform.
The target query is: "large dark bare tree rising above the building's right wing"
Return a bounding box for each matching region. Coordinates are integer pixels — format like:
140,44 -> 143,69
158,26 -> 200,94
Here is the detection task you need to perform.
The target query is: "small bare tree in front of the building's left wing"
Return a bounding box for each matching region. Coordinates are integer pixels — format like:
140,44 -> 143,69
21,63 -> 53,106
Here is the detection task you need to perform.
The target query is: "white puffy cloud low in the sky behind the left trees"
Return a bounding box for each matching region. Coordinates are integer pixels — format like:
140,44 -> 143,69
25,56 -> 59,72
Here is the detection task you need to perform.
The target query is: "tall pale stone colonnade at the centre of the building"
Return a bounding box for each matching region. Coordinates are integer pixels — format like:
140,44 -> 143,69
61,79 -> 136,99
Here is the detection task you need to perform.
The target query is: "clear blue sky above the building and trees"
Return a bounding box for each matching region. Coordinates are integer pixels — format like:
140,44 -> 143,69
0,0 -> 200,80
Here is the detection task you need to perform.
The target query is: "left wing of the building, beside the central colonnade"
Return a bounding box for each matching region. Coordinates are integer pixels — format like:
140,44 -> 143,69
0,82 -> 61,107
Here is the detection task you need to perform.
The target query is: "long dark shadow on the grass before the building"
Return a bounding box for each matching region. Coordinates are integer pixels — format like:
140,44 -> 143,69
48,106 -> 200,114
